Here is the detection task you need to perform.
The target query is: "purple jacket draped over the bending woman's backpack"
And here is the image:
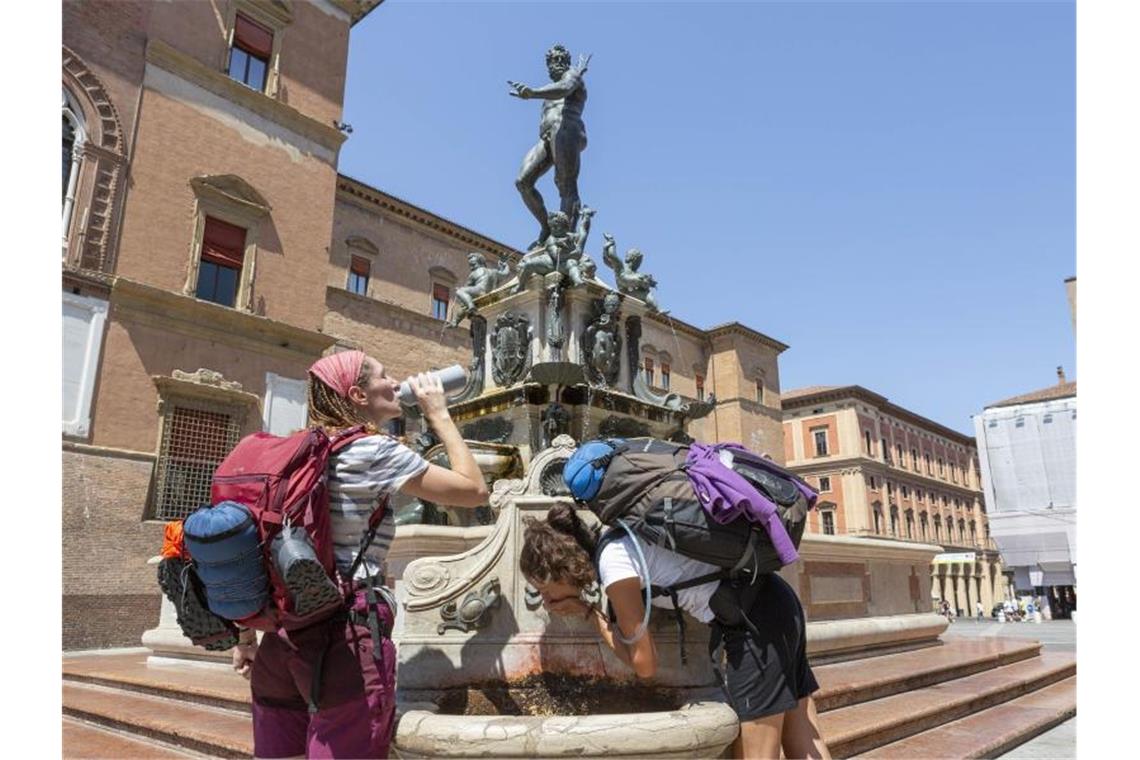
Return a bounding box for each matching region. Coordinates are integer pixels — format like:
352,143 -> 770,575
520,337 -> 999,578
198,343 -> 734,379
686,442 -> 817,565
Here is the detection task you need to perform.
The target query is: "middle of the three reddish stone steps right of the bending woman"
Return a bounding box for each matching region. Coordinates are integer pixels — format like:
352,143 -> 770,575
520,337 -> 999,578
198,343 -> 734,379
820,653 -> 1076,758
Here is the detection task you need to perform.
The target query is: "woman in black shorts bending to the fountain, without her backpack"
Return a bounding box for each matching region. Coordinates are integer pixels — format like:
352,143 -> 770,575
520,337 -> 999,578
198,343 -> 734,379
520,504 -> 831,759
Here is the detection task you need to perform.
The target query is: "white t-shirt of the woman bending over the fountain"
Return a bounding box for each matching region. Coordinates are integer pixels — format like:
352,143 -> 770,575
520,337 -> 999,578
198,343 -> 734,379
597,528 -> 720,623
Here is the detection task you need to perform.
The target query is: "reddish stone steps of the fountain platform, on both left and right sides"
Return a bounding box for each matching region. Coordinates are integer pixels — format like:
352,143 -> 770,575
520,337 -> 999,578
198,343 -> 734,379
64,639 -> 1076,758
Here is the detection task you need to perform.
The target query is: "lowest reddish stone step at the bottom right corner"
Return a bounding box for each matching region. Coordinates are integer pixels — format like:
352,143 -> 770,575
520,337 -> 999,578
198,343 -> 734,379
858,677 -> 1076,760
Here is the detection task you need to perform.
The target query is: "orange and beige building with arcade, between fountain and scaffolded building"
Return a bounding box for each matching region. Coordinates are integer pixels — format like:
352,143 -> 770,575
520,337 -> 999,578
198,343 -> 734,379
781,385 -> 1009,615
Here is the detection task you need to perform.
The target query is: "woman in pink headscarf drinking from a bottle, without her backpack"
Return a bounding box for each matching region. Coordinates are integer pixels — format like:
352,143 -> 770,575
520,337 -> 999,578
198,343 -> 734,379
233,351 -> 487,758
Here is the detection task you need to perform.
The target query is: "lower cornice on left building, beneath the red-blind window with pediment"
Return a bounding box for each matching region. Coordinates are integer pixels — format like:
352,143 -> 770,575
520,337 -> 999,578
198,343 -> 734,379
111,277 -> 335,358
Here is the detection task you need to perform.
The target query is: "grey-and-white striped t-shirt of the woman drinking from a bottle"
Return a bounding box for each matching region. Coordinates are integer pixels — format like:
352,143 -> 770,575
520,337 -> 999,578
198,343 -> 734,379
328,435 -> 428,578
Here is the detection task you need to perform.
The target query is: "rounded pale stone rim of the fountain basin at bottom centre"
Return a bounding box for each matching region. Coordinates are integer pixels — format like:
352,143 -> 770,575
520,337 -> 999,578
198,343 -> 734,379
393,690 -> 740,759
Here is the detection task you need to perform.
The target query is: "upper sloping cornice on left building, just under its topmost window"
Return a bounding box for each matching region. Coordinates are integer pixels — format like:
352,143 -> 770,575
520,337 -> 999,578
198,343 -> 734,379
146,40 -> 348,154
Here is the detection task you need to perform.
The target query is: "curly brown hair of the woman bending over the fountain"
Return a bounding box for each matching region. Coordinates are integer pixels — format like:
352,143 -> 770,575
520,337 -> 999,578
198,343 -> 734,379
519,504 -> 597,588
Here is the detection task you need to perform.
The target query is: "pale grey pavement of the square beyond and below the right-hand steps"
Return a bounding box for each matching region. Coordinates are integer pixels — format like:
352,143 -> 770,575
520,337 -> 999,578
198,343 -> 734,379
943,619 -> 1076,760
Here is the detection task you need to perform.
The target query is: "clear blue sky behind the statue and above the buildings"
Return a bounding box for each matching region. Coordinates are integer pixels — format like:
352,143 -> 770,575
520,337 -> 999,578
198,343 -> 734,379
340,0 -> 1076,434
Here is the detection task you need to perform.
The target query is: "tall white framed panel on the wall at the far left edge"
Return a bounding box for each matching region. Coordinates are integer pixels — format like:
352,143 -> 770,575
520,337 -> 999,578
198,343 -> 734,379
63,293 -> 107,435
